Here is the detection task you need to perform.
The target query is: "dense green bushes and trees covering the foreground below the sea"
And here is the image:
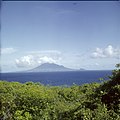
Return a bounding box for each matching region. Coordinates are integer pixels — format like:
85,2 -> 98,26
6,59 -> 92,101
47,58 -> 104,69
0,64 -> 120,120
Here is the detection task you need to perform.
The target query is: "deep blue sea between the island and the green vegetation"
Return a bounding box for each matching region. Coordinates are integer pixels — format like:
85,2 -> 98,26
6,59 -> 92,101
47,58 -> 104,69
1,70 -> 112,86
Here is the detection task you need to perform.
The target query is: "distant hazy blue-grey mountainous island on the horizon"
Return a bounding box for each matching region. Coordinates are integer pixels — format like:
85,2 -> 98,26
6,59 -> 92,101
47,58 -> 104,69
27,63 -> 85,72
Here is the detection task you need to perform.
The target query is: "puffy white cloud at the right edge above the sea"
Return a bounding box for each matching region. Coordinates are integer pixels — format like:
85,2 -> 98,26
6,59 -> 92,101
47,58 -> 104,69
91,45 -> 120,59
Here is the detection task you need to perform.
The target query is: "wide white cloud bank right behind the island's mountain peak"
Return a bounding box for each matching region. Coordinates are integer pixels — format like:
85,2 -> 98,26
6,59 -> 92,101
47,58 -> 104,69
15,51 -> 61,67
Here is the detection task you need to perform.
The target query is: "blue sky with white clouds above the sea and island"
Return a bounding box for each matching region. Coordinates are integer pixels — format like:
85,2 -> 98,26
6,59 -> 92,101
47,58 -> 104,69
1,1 -> 120,72
